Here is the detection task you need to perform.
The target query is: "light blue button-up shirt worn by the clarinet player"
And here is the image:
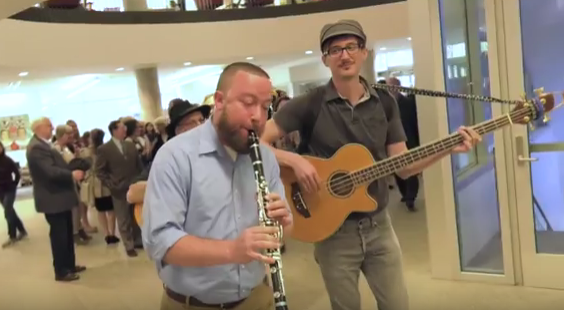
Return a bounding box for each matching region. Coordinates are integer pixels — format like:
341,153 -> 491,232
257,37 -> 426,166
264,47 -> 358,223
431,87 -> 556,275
142,120 -> 284,303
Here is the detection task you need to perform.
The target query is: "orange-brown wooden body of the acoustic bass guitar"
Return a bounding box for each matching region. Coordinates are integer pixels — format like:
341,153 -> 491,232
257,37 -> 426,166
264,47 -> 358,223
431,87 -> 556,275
280,144 -> 377,243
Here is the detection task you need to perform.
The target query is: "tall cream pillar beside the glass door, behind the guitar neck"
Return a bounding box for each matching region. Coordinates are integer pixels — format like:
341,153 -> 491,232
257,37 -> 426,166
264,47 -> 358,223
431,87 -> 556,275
407,0 -> 459,279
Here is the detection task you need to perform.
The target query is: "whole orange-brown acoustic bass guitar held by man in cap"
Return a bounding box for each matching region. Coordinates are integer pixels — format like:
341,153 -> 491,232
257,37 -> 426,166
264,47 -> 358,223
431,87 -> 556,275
280,93 -> 555,242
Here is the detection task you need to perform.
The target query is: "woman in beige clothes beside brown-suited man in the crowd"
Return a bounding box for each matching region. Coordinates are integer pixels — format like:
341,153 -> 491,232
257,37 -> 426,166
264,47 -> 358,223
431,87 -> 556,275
81,129 -> 120,245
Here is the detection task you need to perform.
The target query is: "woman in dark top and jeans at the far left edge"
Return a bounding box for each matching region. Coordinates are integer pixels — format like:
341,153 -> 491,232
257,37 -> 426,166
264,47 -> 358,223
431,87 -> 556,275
0,142 -> 27,248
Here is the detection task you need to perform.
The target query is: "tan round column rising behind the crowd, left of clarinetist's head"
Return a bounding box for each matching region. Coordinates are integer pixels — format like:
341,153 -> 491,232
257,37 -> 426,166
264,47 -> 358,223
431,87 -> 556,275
135,67 -> 163,121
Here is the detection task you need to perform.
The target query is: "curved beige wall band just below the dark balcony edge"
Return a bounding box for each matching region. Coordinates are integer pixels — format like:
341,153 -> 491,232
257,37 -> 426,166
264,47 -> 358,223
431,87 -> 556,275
0,2 -> 409,68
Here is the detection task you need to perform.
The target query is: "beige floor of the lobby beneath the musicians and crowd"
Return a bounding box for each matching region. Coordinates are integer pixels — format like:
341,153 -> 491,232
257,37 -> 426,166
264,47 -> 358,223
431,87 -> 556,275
0,188 -> 564,310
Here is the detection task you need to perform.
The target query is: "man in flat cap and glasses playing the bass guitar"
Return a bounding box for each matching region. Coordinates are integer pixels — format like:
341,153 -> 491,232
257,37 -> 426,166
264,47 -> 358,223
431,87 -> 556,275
261,20 -> 480,310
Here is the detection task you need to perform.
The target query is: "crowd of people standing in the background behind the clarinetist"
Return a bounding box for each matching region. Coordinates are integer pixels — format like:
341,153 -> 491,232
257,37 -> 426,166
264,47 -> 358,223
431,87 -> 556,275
0,91 -> 293,281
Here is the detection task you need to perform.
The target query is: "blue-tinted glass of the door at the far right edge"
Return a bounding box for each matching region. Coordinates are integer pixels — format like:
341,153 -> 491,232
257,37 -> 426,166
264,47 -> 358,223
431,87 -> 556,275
520,0 -> 564,254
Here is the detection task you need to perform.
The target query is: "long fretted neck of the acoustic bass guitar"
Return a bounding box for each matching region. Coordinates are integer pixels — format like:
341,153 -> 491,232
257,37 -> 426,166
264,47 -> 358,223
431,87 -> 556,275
351,108 -> 534,185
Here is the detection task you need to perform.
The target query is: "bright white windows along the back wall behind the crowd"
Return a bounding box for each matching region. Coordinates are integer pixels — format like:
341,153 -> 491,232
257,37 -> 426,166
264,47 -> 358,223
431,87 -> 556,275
0,65 -> 298,166
